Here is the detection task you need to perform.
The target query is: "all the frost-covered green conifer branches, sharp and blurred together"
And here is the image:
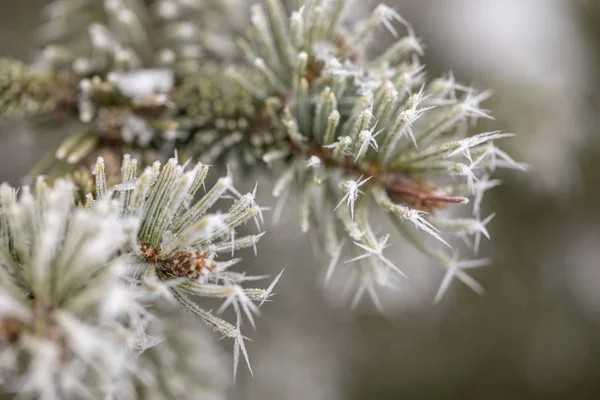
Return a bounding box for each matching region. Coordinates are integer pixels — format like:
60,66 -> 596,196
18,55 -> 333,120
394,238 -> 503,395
0,0 -> 525,399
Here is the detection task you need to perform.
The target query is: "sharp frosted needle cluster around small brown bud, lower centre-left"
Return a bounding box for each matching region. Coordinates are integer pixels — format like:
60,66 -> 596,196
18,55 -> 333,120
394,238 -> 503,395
88,155 -> 279,372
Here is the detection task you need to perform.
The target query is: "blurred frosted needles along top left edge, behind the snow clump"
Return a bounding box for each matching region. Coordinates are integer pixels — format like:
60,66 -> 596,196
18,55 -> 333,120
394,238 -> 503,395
38,0 -> 238,78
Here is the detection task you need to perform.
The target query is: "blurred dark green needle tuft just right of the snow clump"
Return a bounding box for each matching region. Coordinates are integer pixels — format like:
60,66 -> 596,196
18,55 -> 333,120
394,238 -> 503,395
170,65 -> 285,172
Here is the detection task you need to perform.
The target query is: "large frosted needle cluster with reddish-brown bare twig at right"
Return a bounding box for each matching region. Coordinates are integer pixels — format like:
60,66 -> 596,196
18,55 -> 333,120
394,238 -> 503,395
198,0 -> 524,307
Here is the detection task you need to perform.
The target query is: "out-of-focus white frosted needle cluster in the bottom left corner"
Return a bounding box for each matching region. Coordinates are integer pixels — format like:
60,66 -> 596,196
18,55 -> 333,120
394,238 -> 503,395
0,179 -> 148,400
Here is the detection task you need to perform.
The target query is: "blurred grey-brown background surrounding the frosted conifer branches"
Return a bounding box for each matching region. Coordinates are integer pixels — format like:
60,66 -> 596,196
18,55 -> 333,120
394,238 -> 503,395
0,0 -> 600,400
